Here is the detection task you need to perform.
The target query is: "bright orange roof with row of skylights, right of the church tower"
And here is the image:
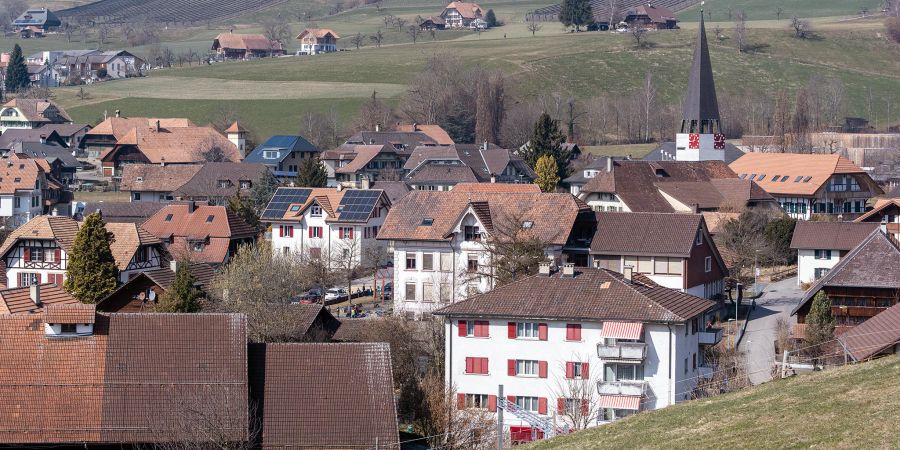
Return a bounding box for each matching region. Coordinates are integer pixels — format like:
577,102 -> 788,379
730,153 -> 881,195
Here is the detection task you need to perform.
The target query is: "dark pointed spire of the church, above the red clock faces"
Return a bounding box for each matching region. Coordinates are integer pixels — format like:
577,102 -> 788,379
681,9 -> 722,134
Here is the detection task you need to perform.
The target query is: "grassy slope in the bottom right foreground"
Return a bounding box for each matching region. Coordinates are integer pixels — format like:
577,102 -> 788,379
533,356 -> 900,449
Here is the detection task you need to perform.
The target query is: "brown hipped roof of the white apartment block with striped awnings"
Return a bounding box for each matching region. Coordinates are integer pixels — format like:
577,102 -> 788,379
435,268 -> 715,322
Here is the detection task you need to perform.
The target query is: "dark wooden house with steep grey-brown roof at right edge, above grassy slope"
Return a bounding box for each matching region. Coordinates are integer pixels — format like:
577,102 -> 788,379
791,229 -> 900,330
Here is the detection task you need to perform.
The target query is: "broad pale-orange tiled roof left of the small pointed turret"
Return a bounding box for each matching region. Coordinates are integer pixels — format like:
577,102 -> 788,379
100,127 -> 241,164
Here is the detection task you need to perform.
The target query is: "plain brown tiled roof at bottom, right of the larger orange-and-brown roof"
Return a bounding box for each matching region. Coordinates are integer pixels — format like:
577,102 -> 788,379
250,343 -> 400,450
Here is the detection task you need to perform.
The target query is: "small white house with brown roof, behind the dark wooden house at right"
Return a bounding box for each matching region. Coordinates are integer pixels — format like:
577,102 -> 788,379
791,221 -> 878,286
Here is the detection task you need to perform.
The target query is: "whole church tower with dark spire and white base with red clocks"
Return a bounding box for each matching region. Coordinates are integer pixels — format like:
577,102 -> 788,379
675,9 -> 725,161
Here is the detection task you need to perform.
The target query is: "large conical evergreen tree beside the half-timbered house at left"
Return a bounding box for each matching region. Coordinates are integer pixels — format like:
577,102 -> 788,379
64,213 -> 119,303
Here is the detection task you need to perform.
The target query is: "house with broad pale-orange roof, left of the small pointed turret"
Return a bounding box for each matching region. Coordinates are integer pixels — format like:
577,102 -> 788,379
100,121 -> 241,178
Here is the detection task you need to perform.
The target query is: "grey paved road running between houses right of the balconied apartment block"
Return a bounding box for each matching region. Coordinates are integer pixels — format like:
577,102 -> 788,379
740,277 -> 803,384
